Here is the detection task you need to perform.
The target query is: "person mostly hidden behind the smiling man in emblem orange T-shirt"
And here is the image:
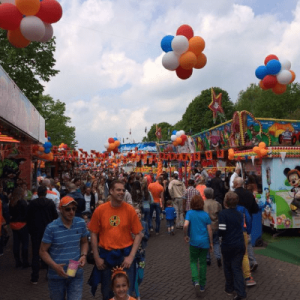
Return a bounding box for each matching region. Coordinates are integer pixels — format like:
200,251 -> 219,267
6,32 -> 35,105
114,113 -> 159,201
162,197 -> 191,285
134,208 -> 149,300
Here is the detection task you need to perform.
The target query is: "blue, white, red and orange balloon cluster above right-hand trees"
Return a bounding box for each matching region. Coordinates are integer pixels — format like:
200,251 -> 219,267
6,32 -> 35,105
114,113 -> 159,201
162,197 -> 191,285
255,54 -> 296,95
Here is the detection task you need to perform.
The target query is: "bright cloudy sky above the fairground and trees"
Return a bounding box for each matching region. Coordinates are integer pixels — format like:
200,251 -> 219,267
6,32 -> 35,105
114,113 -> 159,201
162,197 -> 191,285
45,0 -> 300,151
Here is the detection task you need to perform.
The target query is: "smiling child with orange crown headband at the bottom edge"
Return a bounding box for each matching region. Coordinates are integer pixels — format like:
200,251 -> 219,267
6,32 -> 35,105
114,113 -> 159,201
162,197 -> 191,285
110,268 -> 136,300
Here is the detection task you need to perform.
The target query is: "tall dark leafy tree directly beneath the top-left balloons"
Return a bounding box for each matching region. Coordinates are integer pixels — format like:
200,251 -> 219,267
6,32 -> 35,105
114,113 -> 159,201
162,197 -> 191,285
0,29 -> 59,105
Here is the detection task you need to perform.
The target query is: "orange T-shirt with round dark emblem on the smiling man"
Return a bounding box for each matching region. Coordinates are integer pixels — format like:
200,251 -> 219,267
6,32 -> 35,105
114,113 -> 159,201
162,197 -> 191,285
88,202 -> 143,250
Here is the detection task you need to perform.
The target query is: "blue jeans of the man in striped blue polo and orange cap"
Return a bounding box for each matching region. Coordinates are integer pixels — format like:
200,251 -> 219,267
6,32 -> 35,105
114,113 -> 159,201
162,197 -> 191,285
48,269 -> 83,300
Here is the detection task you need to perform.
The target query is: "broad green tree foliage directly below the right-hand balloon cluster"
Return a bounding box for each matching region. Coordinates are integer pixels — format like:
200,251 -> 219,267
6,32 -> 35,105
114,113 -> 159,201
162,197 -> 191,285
235,83 -> 300,120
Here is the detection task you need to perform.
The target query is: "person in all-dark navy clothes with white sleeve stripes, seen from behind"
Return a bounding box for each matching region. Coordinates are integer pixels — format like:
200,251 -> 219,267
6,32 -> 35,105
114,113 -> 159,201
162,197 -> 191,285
219,192 -> 247,300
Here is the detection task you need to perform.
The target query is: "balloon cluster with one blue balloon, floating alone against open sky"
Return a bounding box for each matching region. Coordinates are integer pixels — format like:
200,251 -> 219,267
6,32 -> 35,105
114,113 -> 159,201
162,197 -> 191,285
161,25 -> 207,79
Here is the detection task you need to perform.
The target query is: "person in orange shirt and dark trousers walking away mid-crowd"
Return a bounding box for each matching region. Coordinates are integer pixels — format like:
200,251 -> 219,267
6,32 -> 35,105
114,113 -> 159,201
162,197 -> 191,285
148,176 -> 164,235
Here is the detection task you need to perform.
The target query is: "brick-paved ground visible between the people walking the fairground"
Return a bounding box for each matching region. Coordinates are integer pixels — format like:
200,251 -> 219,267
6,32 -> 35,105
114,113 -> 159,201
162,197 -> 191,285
0,219 -> 300,300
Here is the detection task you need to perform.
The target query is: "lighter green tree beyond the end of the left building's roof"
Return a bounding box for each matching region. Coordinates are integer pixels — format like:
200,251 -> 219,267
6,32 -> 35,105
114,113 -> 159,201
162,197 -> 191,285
35,95 -> 77,148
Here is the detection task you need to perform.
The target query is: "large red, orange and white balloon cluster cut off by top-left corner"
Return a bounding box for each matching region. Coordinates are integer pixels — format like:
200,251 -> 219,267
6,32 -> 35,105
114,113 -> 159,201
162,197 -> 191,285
0,0 -> 62,48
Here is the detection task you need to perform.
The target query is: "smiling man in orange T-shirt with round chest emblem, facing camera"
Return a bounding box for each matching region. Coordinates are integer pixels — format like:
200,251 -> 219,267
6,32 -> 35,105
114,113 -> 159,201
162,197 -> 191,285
89,180 -> 143,300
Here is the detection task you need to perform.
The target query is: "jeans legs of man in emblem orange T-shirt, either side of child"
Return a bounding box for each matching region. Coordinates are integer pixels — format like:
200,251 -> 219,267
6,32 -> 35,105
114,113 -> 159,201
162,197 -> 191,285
101,259 -> 136,300
